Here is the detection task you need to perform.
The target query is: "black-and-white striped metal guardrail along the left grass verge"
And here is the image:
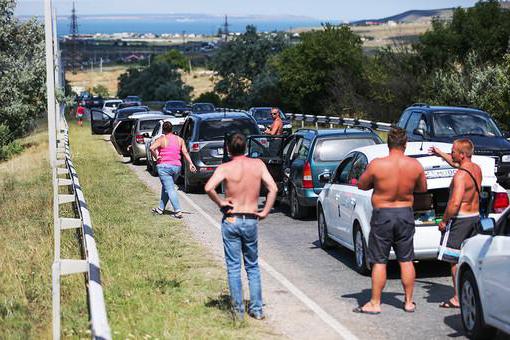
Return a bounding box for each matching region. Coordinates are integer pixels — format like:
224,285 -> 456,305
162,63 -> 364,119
52,120 -> 111,339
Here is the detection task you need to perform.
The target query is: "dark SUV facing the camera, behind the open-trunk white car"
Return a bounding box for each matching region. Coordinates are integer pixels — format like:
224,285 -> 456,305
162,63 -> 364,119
397,104 -> 510,187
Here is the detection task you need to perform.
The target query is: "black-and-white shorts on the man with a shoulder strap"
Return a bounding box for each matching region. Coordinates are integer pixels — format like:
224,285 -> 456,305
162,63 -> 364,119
438,215 -> 480,263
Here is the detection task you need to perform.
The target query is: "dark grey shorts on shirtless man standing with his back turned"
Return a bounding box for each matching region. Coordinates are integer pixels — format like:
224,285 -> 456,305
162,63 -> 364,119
368,207 -> 415,264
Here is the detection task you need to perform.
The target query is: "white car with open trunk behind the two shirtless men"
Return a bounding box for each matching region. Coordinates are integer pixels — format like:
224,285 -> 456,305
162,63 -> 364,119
317,142 -> 508,274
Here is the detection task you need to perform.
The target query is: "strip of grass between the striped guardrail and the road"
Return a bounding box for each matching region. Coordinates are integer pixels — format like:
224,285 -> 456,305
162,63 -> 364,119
63,121 -> 280,338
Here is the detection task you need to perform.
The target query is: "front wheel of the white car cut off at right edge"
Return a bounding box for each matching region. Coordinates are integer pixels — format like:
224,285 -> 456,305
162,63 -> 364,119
459,270 -> 496,340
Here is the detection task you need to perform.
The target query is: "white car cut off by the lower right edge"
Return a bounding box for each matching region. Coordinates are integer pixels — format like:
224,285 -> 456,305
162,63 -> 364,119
457,209 -> 510,339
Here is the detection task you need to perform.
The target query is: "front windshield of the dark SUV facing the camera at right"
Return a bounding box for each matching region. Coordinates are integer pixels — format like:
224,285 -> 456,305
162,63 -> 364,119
433,112 -> 501,137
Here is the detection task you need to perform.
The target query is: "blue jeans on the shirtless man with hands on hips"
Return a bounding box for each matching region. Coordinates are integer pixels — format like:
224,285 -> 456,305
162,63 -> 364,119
221,217 -> 262,317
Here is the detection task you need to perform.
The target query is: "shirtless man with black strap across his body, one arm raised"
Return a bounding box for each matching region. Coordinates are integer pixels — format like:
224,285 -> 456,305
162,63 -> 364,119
429,139 -> 482,308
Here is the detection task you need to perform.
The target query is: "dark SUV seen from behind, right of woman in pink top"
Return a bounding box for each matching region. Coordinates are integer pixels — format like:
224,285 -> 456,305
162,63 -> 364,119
180,111 -> 260,192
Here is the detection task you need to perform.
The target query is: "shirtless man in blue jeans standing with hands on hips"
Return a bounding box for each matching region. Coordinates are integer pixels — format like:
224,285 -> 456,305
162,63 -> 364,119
205,133 -> 277,320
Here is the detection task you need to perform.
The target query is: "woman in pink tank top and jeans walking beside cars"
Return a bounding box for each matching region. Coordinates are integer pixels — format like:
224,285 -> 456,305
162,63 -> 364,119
150,122 -> 197,218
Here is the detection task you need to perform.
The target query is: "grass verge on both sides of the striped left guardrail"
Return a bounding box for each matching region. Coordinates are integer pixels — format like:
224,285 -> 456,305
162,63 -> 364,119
0,121 -> 278,339
